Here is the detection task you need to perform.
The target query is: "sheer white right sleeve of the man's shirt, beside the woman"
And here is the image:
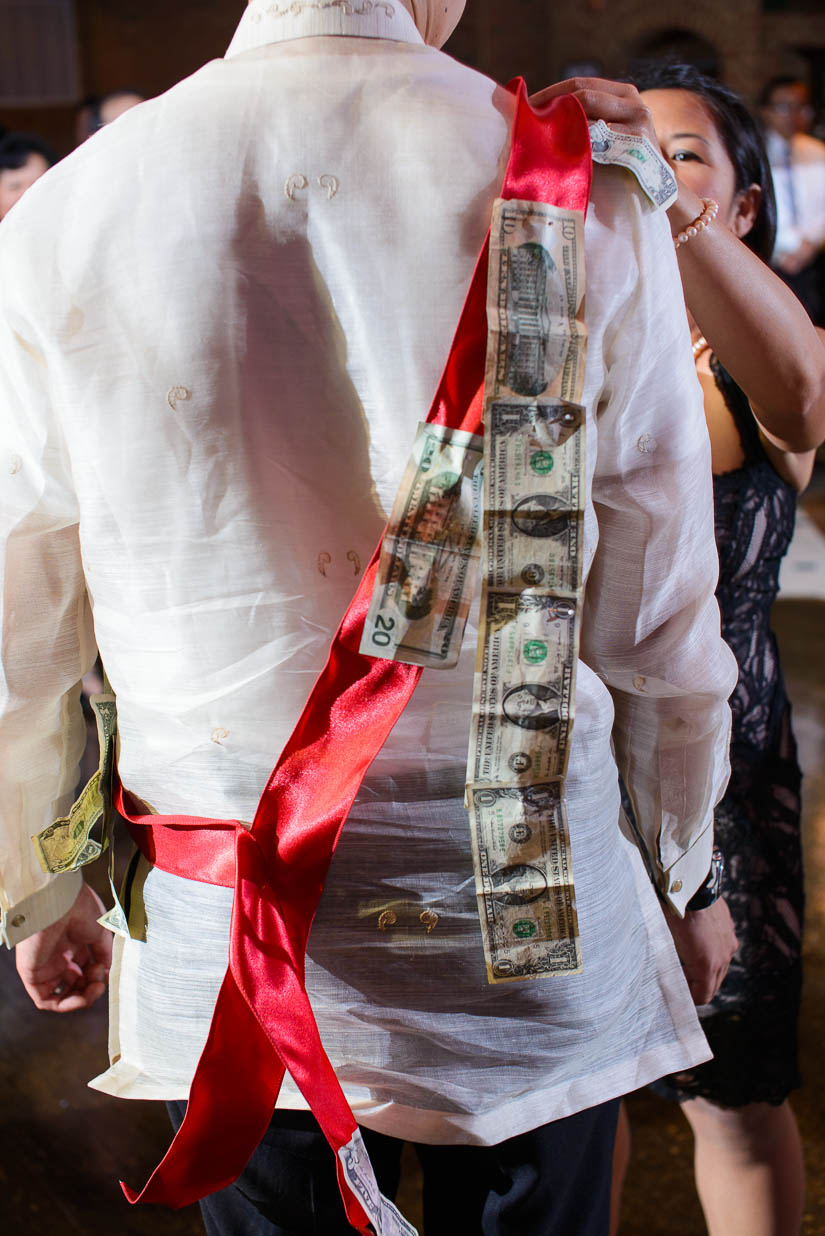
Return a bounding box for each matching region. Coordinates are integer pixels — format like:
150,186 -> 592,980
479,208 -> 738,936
581,192 -> 737,913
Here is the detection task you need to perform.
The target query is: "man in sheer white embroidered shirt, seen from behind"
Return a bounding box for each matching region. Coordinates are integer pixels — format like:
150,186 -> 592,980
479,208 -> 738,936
0,0 -> 736,1236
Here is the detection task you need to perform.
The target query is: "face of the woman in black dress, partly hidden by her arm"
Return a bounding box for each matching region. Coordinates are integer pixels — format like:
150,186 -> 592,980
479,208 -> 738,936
642,90 -> 753,236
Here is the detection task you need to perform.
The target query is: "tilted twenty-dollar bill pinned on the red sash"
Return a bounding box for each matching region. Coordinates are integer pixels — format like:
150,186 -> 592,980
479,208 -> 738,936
361,424 -> 482,669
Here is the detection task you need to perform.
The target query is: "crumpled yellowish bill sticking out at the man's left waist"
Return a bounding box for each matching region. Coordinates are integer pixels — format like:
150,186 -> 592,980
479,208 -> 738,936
32,695 -> 118,875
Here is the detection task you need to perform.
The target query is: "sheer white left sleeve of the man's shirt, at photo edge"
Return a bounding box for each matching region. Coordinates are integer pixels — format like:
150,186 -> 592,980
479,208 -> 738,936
0,238 -> 95,947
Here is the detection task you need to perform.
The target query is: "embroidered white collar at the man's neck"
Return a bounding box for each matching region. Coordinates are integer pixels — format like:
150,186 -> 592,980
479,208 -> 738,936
226,0 -> 423,58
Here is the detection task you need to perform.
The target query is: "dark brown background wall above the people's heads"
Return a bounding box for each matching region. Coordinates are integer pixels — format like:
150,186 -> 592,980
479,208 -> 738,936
0,0 -> 825,153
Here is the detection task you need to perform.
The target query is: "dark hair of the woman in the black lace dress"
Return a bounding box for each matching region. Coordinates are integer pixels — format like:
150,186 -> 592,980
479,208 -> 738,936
632,64 -> 777,262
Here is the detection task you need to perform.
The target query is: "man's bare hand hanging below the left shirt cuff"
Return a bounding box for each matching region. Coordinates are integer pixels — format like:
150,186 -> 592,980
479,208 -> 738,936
15,884 -> 111,1012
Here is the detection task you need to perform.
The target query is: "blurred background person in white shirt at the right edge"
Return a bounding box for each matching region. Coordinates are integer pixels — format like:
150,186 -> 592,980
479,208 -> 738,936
759,77 -> 825,326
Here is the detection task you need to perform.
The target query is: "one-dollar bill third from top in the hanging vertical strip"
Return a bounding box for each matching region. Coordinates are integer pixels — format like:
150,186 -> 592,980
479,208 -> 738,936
468,590 -> 576,786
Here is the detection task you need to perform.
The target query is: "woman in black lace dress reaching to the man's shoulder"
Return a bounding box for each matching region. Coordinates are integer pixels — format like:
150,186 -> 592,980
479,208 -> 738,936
531,66 -> 825,1236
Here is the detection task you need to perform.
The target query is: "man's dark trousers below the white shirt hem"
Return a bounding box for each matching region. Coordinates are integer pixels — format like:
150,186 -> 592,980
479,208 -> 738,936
167,1099 -> 618,1236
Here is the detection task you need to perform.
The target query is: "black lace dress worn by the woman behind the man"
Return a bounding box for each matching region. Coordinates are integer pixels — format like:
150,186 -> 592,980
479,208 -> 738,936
654,361 -> 803,1107
